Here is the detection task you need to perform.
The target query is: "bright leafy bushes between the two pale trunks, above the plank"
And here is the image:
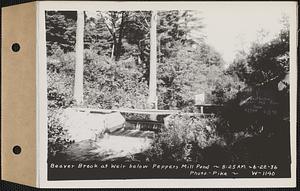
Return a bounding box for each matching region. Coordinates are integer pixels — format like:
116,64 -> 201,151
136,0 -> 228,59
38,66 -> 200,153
84,51 -> 148,109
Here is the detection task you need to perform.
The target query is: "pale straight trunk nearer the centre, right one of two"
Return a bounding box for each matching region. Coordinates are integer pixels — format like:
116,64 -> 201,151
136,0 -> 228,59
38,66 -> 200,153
148,10 -> 157,109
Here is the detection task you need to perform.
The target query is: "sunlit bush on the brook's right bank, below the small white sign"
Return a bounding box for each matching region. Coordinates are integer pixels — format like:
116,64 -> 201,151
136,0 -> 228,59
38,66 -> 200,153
147,114 -> 225,162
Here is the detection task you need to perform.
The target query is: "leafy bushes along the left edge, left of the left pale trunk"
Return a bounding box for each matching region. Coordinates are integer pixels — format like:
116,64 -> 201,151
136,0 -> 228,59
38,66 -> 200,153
47,51 -> 74,159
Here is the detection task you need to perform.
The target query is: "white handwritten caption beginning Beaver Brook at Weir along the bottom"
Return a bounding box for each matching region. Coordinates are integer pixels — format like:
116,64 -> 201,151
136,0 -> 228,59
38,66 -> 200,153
49,163 -> 278,177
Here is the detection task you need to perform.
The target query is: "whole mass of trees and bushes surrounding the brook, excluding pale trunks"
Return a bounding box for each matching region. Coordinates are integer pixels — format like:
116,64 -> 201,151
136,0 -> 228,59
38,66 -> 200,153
45,10 -> 290,163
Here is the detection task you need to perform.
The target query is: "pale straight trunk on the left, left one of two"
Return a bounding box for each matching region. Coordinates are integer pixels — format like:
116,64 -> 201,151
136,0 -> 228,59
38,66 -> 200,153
74,11 -> 84,105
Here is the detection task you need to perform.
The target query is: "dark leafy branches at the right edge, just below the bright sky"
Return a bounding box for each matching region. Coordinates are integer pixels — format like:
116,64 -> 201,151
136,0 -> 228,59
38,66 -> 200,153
228,21 -> 289,86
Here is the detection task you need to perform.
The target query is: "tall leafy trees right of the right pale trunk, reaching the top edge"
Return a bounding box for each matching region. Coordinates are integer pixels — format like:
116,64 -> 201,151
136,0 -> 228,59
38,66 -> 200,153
157,11 -> 243,109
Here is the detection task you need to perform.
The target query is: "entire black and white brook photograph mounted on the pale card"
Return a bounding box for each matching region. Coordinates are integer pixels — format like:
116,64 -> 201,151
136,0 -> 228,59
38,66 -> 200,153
42,0 -> 292,184
